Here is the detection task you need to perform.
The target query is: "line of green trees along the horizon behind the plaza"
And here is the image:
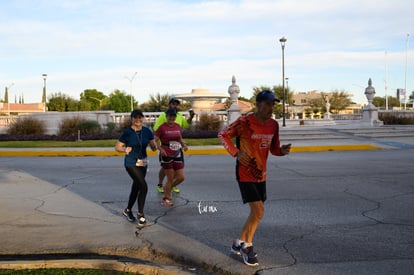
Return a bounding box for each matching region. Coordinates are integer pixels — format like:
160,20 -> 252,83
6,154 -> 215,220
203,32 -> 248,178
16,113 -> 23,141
46,85 -> 414,114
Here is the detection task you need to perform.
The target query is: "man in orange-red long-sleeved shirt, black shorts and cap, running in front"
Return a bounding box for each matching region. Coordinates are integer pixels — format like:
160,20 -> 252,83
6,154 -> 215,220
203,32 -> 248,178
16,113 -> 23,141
218,90 -> 290,266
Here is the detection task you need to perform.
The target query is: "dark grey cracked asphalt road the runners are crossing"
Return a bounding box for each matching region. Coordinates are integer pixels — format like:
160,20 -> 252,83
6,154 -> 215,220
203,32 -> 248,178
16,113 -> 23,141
0,148 -> 414,274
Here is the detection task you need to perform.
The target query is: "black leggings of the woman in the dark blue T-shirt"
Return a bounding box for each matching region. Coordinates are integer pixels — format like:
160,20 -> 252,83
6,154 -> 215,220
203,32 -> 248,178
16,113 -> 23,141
126,166 -> 148,214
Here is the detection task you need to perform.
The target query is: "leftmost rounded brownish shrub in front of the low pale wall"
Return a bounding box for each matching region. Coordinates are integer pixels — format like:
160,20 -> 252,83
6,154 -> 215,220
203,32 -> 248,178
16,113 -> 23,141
7,116 -> 46,136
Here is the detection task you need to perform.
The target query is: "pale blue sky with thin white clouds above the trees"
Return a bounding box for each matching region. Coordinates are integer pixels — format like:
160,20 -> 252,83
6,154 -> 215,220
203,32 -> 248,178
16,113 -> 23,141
0,0 -> 414,104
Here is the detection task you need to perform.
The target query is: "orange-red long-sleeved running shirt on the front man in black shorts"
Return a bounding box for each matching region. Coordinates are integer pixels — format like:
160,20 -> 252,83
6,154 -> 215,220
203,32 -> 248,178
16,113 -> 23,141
218,113 -> 283,182
